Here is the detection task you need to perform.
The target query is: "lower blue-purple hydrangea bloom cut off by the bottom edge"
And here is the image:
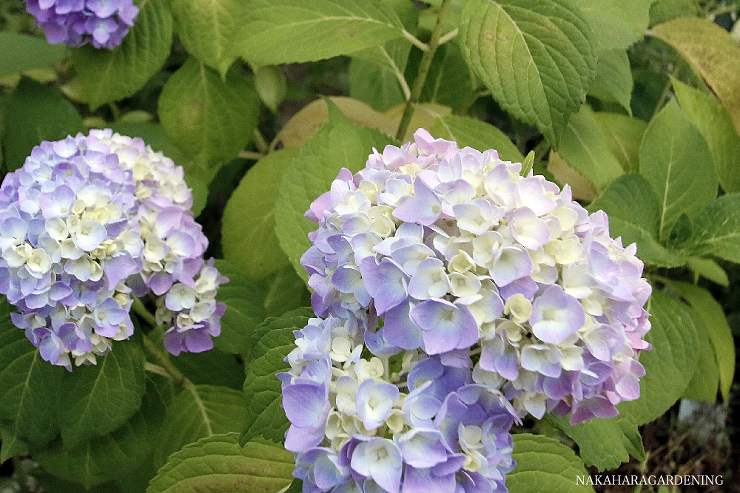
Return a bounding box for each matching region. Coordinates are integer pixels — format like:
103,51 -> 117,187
278,316 -> 518,493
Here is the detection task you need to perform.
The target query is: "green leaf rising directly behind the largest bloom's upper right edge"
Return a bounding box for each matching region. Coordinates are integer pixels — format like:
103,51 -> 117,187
588,174 -> 685,267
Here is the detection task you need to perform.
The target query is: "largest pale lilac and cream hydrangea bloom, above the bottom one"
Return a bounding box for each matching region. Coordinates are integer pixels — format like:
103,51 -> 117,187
301,130 -> 651,423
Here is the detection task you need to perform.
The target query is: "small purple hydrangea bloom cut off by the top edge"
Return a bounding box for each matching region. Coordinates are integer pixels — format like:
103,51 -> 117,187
26,0 -> 139,50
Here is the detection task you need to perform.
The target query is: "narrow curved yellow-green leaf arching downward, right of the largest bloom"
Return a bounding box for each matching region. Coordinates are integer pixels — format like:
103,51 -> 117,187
668,281 -> 735,402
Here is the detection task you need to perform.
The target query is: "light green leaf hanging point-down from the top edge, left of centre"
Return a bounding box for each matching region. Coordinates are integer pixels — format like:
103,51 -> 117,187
171,0 -> 249,77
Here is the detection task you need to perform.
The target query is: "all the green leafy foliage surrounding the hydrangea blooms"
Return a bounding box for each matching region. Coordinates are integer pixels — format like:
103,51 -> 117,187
0,0 -> 740,492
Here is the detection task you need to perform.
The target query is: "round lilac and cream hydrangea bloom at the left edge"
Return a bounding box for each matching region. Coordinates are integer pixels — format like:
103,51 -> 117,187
0,129 -> 228,370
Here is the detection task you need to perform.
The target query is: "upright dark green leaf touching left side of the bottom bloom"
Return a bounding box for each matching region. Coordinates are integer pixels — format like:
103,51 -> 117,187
240,308 -> 313,443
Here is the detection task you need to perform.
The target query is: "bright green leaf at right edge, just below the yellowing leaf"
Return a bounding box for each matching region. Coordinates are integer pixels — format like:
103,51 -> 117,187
673,79 -> 740,192
